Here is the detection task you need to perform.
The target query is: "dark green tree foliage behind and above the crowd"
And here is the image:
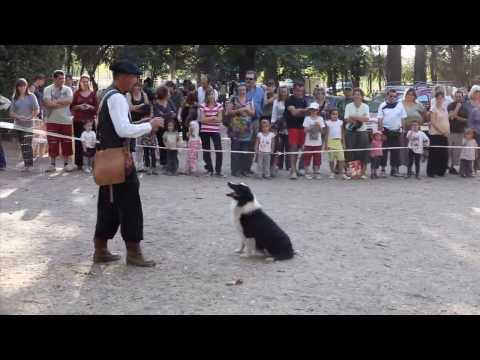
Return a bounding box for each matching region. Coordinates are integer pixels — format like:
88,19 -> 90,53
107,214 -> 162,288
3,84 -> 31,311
0,45 -> 480,96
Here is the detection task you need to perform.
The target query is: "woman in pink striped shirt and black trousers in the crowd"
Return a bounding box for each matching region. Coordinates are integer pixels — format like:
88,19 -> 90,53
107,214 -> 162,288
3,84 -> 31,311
200,87 -> 224,177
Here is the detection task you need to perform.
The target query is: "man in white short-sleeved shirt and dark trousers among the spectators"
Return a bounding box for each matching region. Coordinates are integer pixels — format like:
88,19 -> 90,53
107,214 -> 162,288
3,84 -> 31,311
377,89 -> 407,177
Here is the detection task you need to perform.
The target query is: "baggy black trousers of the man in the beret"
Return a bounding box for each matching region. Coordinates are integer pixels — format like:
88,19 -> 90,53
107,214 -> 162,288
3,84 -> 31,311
95,169 -> 143,243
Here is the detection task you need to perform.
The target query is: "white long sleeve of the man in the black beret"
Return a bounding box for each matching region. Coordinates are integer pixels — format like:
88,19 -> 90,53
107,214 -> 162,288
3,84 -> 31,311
107,94 -> 152,138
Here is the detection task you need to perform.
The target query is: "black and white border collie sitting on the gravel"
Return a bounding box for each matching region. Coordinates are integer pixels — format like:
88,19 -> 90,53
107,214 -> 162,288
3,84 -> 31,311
227,182 -> 295,260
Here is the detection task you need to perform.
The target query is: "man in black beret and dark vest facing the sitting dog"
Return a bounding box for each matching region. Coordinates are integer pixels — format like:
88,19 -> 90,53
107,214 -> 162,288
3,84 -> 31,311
93,60 -> 163,267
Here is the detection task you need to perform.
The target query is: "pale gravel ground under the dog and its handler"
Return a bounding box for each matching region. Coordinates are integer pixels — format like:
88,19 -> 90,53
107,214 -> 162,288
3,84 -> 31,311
0,139 -> 480,314
